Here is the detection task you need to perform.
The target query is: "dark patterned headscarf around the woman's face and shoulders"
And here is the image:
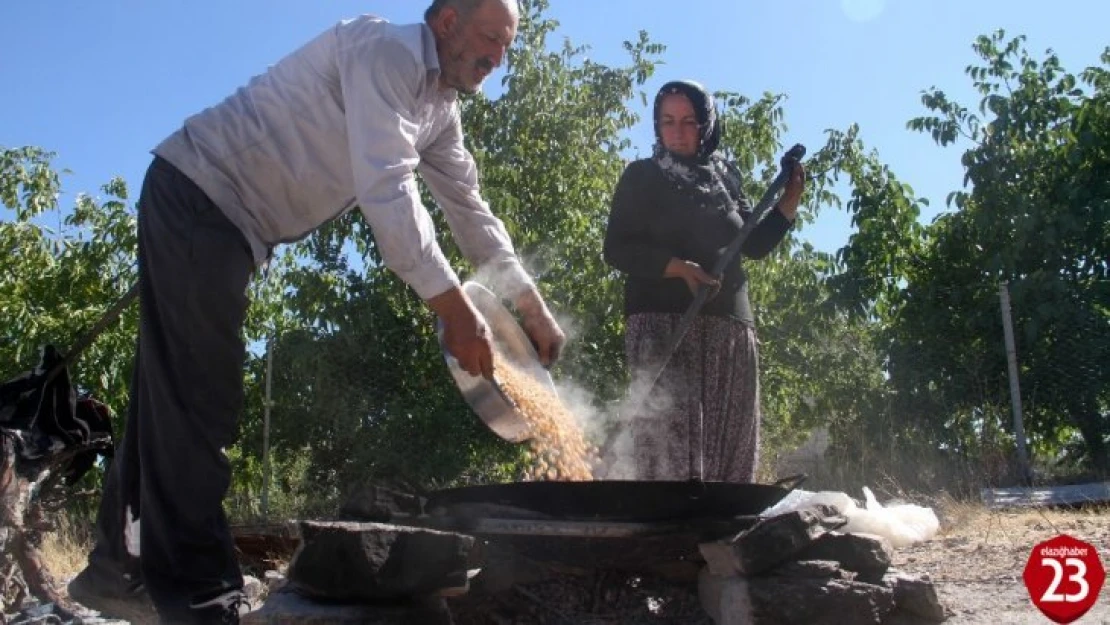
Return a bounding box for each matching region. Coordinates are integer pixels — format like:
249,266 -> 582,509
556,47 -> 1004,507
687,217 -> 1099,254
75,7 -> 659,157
652,80 -> 738,211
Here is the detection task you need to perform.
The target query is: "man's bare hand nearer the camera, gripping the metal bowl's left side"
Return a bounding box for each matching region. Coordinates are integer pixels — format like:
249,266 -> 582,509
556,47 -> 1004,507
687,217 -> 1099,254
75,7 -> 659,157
427,286 -> 493,380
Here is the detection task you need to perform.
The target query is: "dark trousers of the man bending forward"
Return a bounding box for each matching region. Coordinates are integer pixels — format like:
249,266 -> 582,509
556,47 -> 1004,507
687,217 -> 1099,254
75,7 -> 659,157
89,157 -> 254,619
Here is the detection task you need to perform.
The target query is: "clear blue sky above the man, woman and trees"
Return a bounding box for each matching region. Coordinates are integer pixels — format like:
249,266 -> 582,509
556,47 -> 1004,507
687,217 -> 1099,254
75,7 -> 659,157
0,0 -> 1110,251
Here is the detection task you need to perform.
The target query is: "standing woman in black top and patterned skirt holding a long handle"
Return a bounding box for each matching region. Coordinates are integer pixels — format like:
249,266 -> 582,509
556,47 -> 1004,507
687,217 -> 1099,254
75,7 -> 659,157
605,81 -> 805,482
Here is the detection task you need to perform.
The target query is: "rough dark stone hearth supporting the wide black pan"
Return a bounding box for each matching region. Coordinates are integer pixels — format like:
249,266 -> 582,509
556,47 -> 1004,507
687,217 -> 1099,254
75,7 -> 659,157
244,488 -> 946,625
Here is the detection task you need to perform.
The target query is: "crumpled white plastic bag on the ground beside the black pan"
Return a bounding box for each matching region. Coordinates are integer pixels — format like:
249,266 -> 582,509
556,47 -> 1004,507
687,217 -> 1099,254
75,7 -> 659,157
761,486 -> 940,548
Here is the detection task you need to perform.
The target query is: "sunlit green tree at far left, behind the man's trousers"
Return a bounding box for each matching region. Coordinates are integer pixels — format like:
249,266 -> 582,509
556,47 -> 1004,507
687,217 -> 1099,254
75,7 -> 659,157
0,147 -> 137,417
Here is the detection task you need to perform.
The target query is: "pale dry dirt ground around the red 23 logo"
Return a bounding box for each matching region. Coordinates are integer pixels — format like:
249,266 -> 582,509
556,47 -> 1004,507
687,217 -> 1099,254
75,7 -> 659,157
892,504 -> 1110,625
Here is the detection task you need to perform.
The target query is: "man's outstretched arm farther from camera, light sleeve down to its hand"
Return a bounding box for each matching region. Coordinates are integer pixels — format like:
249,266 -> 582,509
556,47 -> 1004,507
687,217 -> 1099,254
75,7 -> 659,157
420,116 -> 566,365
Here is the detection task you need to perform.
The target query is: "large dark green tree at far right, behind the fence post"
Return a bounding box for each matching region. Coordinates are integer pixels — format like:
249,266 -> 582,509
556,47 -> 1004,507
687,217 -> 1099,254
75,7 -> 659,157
896,31 -> 1110,474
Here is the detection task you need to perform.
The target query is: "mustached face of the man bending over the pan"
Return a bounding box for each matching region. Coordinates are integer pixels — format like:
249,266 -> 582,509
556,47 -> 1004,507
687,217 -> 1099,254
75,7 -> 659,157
432,0 -> 517,93
